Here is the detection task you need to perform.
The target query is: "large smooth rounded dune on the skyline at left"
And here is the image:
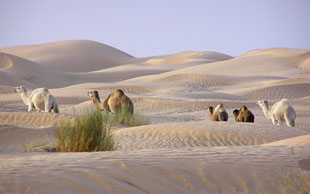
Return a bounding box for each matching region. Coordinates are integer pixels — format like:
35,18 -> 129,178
0,40 -> 133,72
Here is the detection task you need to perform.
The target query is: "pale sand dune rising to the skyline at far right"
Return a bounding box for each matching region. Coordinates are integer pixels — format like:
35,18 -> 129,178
168,49 -> 309,77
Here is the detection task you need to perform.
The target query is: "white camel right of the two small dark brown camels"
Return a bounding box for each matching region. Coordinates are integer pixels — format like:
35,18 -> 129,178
257,99 -> 296,127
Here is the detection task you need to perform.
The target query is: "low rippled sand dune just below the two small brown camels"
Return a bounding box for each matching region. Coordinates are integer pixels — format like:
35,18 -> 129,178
115,120 -> 309,150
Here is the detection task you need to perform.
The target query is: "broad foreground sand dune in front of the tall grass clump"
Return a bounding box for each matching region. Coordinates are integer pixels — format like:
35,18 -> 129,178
0,146 -> 308,193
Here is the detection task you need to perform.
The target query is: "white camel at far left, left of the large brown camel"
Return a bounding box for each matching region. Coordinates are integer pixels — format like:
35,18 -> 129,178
14,86 -> 59,113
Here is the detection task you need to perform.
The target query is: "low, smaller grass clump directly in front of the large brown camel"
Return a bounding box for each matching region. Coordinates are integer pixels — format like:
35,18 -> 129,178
113,106 -> 151,127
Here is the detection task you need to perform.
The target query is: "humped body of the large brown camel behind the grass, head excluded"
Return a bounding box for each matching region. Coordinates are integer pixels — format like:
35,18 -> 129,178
103,89 -> 134,114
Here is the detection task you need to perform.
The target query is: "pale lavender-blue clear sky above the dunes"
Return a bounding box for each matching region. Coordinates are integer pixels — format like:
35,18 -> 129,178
0,0 -> 310,57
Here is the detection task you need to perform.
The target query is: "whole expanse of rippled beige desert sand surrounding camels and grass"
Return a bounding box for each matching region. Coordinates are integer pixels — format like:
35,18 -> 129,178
0,40 -> 310,193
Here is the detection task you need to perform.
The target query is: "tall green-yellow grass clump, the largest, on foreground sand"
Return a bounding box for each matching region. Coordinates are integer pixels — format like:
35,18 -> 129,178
55,108 -> 116,152
